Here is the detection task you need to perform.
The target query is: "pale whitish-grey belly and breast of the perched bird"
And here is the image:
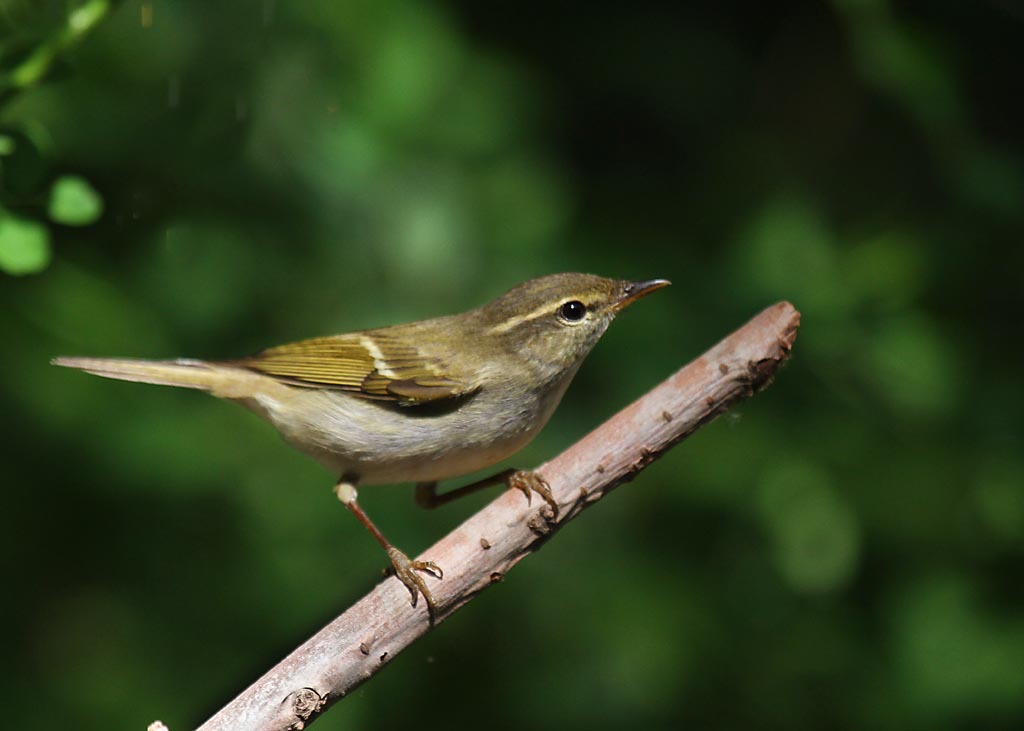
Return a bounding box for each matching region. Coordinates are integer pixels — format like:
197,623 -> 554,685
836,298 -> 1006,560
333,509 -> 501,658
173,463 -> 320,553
243,380 -> 564,484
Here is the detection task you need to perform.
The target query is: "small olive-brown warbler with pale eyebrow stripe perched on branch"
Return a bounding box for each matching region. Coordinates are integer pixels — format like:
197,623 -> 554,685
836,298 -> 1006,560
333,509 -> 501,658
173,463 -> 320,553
53,273 -> 669,614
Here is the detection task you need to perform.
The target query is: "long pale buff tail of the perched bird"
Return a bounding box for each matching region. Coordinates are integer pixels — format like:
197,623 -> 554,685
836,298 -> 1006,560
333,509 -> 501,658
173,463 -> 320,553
50,357 -> 259,398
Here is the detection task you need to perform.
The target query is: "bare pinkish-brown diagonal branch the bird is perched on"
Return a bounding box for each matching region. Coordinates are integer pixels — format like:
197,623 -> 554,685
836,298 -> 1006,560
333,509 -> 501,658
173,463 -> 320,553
190,302 -> 800,731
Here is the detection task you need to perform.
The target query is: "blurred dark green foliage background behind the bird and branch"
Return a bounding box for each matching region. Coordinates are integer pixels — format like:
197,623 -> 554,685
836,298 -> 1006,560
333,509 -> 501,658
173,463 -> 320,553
0,0 -> 1024,730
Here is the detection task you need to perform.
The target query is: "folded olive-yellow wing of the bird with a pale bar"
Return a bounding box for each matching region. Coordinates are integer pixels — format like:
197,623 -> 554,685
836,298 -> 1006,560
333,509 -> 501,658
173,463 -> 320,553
231,331 -> 476,405
